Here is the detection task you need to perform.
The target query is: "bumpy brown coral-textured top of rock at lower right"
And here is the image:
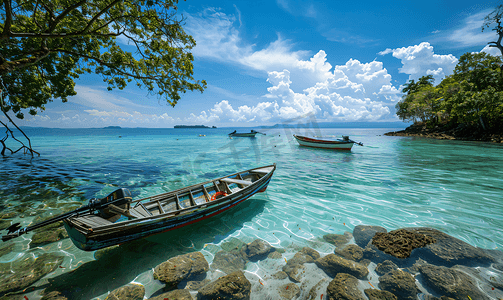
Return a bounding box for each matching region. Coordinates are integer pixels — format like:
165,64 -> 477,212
372,229 -> 435,258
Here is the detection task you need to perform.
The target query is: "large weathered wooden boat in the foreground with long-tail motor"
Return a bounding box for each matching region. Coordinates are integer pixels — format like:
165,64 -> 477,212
2,164 -> 276,251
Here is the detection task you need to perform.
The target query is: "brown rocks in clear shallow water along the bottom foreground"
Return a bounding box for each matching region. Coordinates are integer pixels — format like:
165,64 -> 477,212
0,225 -> 503,300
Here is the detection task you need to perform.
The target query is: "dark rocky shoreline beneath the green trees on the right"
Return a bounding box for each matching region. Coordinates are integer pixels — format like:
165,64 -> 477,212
384,123 -> 503,143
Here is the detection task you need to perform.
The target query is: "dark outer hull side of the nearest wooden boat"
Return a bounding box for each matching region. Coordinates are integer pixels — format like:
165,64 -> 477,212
64,165 -> 274,251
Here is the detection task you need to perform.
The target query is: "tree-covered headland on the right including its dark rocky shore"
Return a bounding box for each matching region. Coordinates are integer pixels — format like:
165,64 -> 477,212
385,52 -> 503,143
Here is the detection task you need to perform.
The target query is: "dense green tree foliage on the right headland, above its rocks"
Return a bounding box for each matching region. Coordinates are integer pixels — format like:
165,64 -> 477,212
396,52 -> 503,130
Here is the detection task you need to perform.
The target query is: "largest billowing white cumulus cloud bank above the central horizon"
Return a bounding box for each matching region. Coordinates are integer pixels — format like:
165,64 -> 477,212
186,51 -> 400,123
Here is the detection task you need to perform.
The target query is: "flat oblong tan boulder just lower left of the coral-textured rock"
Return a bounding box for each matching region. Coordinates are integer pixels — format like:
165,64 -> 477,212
315,254 -> 369,279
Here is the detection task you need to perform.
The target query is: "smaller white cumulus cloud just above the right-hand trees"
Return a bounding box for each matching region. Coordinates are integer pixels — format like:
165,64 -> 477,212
379,42 -> 458,83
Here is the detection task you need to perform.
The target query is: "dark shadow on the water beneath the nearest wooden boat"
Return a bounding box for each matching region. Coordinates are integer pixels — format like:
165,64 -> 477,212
44,198 -> 267,299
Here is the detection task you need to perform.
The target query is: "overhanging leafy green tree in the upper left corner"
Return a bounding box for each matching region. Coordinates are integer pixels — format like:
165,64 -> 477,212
0,0 -> 206,155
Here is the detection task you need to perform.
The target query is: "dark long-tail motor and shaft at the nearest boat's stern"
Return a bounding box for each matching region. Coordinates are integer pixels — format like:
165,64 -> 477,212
2,188 -> 132,242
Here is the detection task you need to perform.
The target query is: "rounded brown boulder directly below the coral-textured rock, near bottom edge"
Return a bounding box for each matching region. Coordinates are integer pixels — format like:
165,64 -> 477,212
379,270 -> 419,300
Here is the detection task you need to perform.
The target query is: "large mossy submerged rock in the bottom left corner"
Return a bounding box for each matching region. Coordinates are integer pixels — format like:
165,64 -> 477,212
0,253 -> 64,295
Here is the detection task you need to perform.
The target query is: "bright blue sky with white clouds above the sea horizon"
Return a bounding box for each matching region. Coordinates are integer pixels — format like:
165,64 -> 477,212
4,0 -> 501,128
